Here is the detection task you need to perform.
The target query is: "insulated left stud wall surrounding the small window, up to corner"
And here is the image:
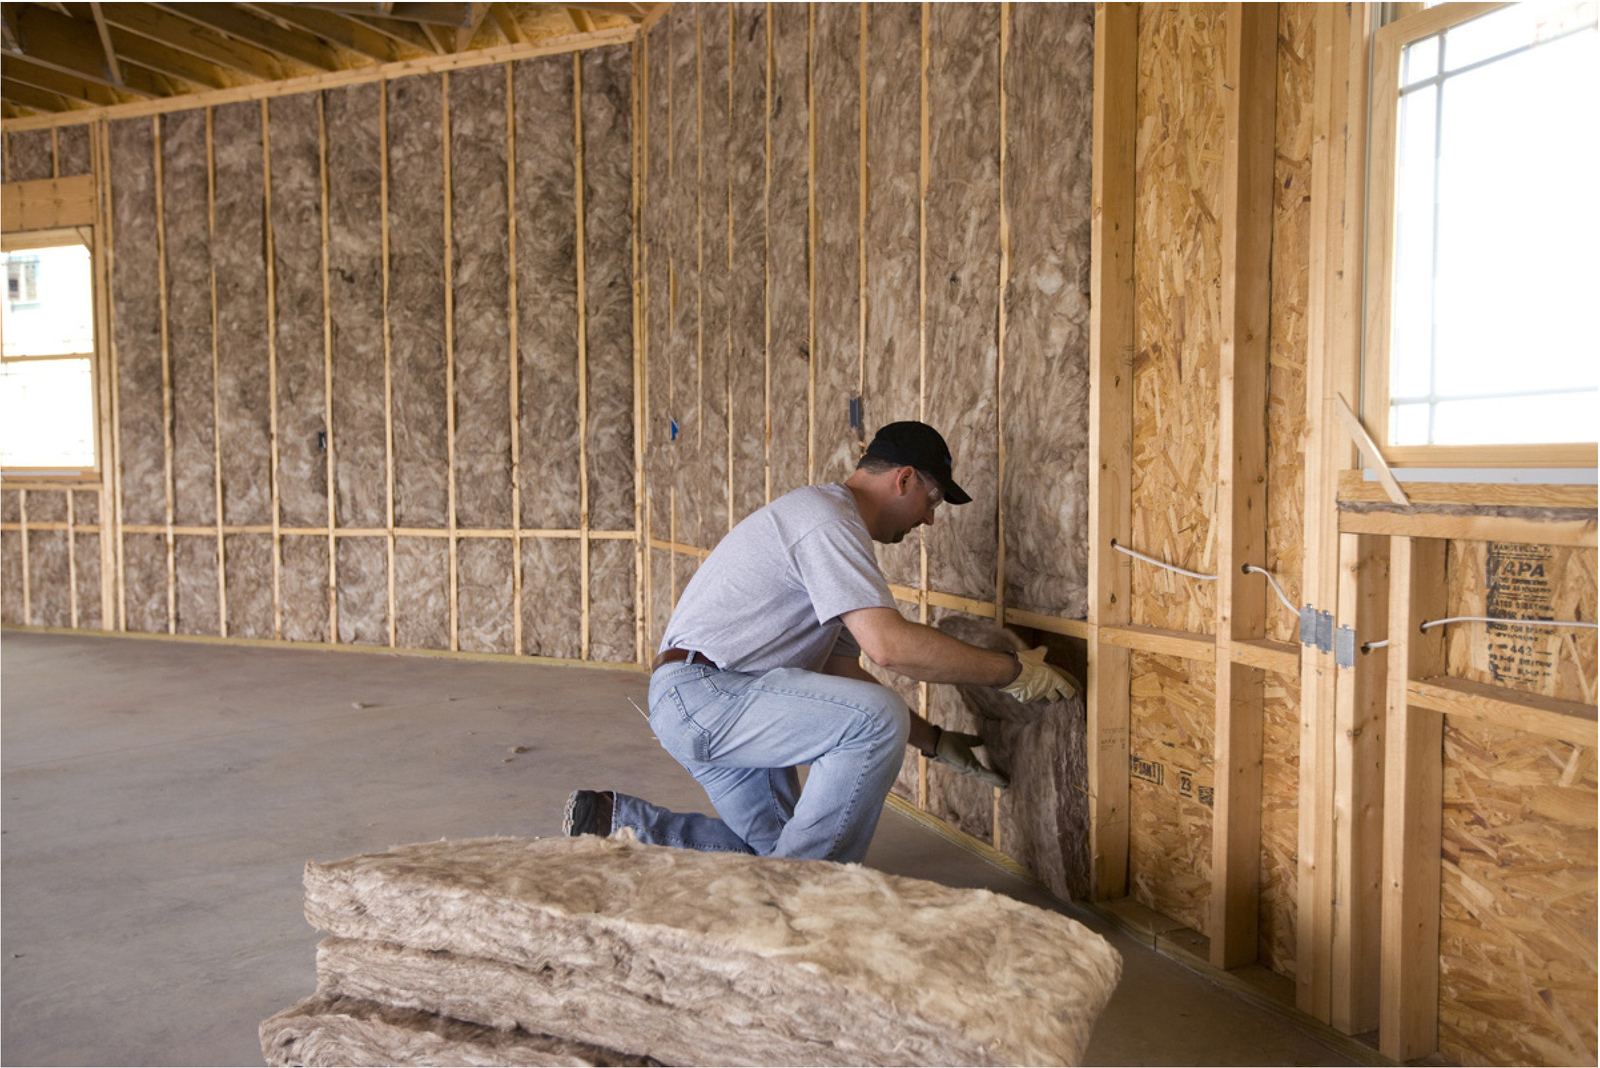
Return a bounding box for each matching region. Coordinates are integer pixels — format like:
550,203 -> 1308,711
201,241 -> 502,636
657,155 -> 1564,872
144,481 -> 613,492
3,45 -> 640,664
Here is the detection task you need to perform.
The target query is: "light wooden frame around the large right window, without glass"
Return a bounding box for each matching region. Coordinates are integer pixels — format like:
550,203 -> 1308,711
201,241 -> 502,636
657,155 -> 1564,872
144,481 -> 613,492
1362,2 -> 1597,468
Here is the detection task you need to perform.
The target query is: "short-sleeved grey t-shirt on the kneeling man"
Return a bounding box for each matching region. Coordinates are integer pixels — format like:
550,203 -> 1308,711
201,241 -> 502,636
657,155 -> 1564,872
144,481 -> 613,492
661,483 -> 894,671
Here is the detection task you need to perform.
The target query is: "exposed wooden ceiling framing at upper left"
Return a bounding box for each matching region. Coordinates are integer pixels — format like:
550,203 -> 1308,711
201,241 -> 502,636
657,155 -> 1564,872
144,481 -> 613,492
0,3 -> 666,118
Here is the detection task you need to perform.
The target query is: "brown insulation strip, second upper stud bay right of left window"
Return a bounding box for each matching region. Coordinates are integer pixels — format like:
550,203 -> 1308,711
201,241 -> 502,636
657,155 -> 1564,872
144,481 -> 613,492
160,110 -> 216,534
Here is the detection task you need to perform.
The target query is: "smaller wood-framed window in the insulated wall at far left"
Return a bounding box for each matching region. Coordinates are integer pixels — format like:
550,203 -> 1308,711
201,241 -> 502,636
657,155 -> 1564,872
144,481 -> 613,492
0,230 -> 96,475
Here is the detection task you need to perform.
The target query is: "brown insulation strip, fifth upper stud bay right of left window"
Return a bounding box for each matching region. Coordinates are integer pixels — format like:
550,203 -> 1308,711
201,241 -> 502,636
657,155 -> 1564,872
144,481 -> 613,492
323,85 -> 389,530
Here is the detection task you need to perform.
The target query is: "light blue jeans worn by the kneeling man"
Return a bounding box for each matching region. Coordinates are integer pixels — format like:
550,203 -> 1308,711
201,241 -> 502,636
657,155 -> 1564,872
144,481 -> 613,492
611,662 -> 910,862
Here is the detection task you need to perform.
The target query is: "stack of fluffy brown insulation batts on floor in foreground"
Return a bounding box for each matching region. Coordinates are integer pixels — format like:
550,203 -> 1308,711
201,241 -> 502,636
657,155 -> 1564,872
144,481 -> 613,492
261,831 -> 1122,1065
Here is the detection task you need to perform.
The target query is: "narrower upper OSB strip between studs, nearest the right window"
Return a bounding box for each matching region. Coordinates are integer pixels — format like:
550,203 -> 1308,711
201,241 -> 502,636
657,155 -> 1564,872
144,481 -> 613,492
1251,3 -> 1315,641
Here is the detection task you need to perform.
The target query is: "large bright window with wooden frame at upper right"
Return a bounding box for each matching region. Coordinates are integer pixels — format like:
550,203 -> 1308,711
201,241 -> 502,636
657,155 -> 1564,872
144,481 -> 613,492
1366,0 -> 1600,467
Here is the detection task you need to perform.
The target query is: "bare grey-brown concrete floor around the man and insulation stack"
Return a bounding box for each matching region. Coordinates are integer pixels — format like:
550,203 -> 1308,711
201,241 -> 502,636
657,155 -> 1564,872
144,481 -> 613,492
0,632 -> 1352,1065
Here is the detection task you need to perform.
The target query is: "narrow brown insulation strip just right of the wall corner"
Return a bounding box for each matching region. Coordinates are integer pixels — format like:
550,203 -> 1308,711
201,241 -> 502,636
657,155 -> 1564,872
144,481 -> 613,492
642,32 -> 678,546
